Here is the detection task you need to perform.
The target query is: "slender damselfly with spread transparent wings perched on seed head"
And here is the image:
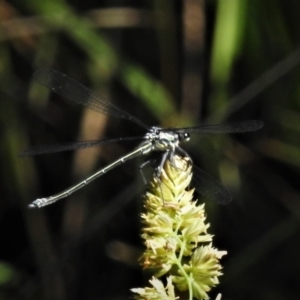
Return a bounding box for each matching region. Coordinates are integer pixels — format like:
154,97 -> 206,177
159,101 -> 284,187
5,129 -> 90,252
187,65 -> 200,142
21,69 -> 263,208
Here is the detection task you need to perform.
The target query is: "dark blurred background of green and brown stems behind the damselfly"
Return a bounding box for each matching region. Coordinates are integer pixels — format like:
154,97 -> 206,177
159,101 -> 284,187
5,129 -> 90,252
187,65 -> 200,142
0,0 -> 300,300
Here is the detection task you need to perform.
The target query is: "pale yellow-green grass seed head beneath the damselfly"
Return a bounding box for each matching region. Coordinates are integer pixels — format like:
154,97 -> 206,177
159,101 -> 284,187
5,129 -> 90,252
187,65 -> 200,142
132,155 -> 226,300
